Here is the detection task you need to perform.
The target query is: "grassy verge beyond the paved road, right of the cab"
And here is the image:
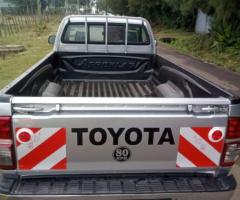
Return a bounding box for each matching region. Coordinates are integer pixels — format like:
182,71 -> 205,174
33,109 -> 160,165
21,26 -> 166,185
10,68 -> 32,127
154,28 -> 240,73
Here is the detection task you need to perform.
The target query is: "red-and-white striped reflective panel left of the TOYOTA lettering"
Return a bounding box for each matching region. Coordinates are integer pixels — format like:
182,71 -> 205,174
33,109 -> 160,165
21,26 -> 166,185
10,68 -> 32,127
16,128 -> 67,170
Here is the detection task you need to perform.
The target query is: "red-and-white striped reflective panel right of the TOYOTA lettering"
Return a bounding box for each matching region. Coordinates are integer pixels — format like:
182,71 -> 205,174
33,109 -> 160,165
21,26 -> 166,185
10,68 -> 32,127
176,127 -> 226,167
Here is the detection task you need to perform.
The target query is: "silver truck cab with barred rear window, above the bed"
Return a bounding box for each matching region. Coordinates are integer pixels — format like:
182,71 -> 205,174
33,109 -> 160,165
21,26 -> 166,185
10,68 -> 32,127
54,15 -> 156,55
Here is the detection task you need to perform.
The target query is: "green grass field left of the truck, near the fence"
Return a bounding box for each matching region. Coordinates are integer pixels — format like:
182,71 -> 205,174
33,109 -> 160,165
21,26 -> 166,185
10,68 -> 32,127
0,20 -> 59,88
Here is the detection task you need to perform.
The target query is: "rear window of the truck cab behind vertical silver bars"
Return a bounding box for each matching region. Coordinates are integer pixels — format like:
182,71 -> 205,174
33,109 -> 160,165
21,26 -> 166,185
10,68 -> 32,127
62,23 -> 150,45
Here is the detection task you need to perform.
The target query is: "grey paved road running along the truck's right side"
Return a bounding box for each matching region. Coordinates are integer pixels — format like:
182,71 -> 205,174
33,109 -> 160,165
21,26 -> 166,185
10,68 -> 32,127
158,45 -> 240,200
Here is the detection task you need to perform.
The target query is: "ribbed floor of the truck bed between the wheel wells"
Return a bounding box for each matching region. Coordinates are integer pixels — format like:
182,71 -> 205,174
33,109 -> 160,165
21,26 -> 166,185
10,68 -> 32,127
61,80 -> 157,97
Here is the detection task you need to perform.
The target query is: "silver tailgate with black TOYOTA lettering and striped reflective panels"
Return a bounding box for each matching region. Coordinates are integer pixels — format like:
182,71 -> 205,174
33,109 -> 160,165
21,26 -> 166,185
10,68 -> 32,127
10,97 -> 229,173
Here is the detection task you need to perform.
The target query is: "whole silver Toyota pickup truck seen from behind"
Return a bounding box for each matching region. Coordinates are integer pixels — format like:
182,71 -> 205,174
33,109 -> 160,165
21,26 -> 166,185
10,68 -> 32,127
0,15 -> 240,200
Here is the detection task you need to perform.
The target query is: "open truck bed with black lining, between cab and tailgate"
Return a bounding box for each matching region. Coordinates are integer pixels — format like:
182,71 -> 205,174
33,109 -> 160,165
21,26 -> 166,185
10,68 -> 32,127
2,53 -> 232,98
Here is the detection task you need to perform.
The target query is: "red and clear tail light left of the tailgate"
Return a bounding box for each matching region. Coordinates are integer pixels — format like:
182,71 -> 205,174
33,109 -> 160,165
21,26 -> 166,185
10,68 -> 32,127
0,117 -> 16,170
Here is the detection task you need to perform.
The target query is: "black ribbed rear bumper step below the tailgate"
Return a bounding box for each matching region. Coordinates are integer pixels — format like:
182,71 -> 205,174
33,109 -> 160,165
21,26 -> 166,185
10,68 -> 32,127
0,174 -> 236,200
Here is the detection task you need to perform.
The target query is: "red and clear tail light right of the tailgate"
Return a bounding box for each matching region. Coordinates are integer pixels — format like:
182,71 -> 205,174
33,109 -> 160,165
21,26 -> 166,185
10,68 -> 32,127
221,117 -> 240,167
